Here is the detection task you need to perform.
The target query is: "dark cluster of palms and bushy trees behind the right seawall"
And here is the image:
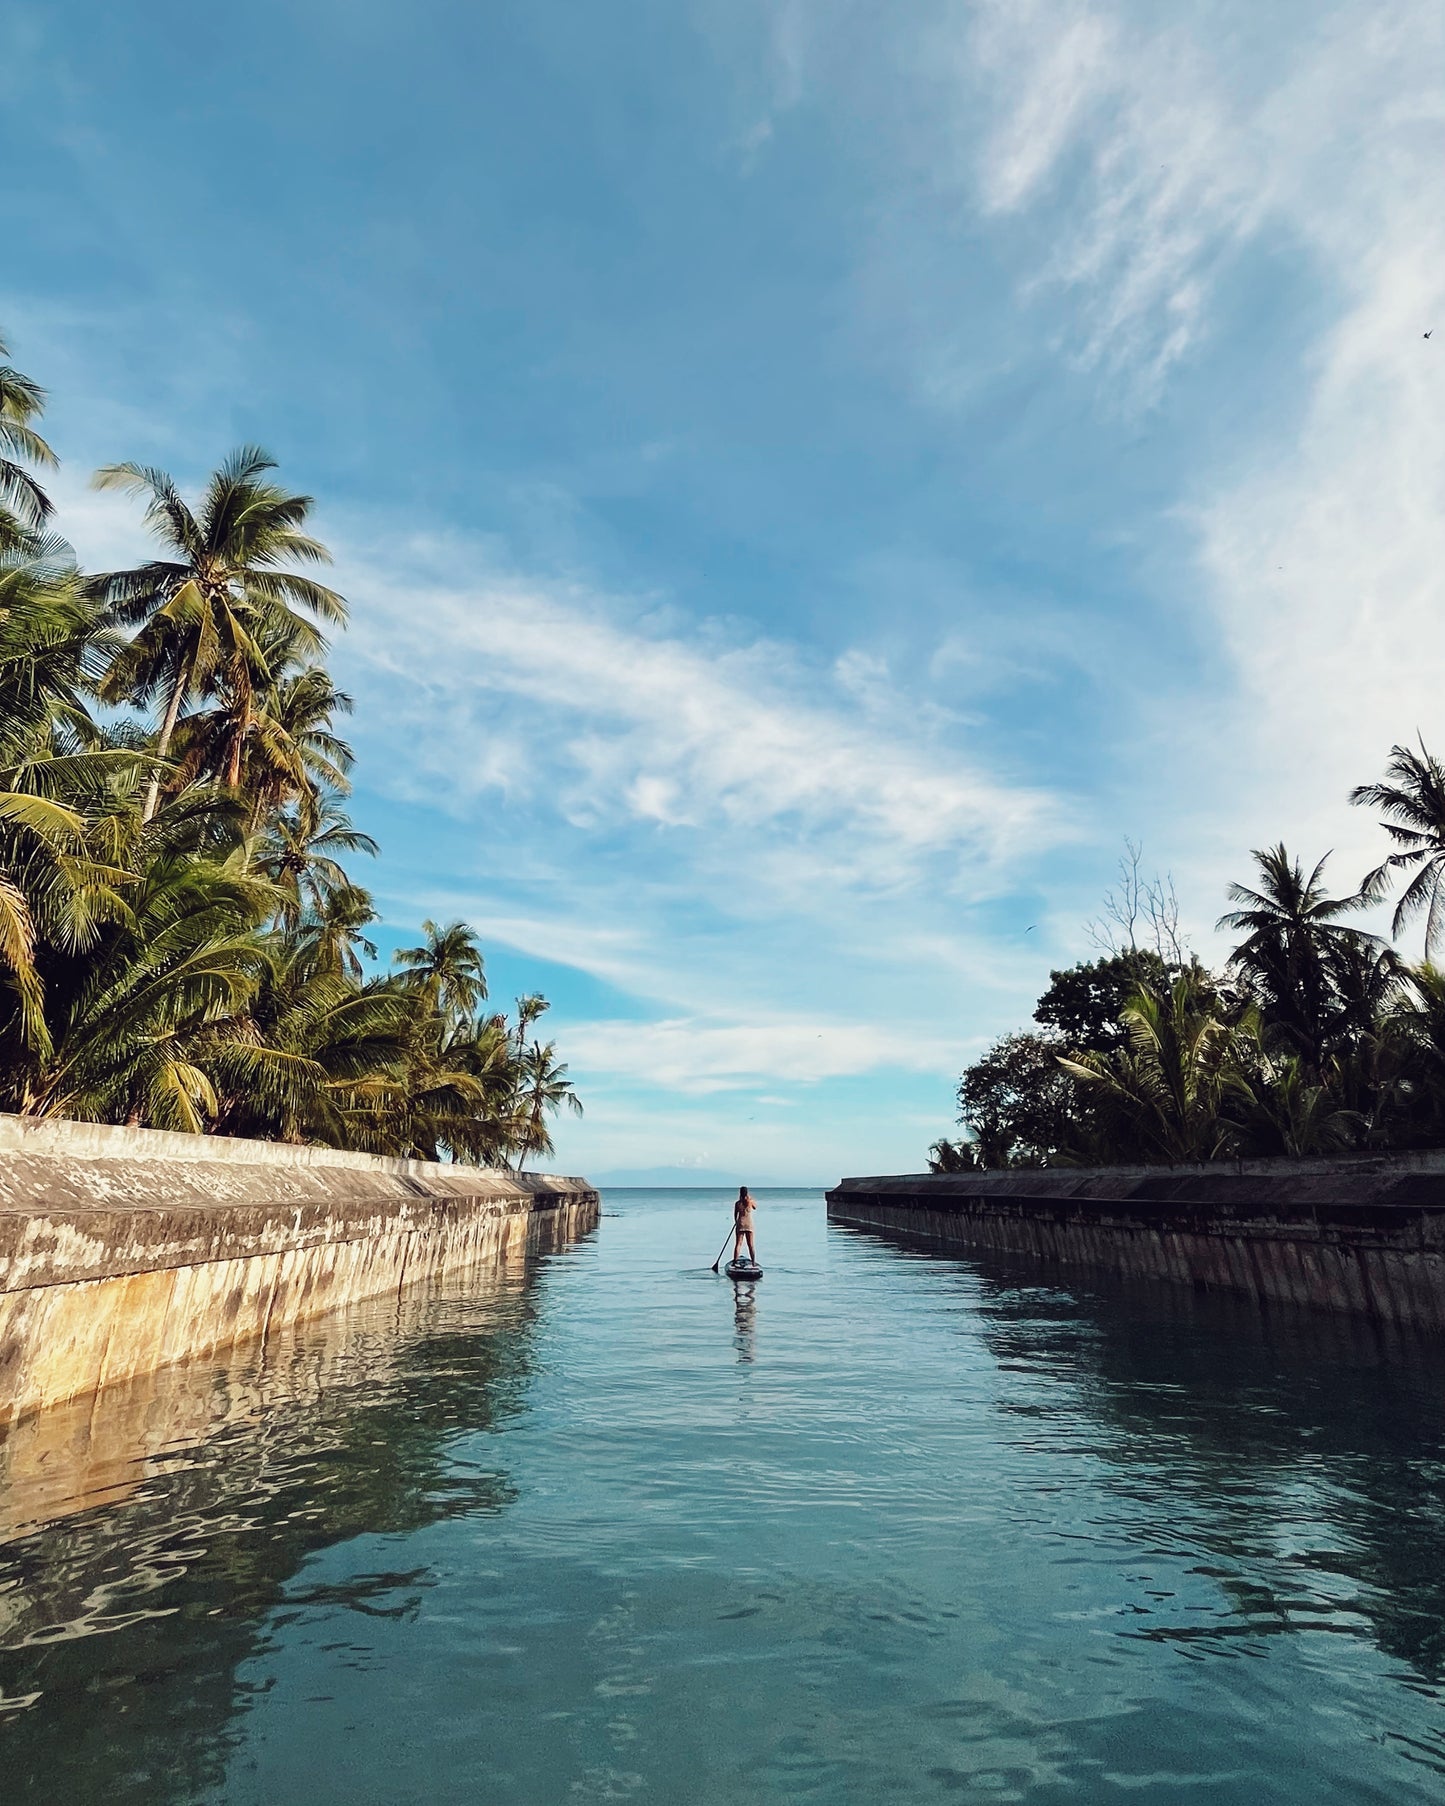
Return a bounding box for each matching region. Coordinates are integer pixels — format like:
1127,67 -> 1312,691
930,758 -> 1445,1172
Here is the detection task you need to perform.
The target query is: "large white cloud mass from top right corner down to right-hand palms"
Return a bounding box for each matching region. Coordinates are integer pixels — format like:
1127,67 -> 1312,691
983,0 -> 1445,924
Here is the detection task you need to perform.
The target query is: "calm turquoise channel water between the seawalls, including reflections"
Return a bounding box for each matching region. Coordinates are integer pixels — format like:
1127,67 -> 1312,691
0,1194 -> 1445,1806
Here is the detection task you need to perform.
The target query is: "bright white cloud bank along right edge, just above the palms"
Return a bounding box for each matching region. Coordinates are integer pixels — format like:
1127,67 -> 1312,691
1198,234 -> 1445,903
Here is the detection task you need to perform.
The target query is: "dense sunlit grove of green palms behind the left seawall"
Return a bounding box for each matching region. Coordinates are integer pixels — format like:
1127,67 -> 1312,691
0,332 -> 580,1165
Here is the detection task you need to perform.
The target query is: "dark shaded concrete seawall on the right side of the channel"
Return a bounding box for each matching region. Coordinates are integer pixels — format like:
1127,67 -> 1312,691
827,1150 -> 1445,1331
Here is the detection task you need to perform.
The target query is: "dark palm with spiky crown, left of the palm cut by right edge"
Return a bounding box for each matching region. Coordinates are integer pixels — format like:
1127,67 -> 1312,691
1216,843 -> 1380,1073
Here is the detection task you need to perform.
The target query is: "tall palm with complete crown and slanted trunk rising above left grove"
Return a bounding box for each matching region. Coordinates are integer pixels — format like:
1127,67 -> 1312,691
90,446 -> 347,820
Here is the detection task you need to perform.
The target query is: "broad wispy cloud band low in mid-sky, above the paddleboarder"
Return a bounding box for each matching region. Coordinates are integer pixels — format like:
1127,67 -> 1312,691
341,542 -> 1078,1107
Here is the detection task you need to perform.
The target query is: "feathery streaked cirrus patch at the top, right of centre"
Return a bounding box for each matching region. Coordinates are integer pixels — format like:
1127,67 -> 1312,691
970,0 -> 1264,403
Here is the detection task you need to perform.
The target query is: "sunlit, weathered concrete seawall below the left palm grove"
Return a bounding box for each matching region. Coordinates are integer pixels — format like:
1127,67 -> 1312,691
0,1116 -> 598,1425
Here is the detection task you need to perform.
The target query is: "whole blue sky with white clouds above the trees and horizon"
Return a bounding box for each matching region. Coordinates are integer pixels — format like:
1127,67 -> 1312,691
0,0 -> 1445,1183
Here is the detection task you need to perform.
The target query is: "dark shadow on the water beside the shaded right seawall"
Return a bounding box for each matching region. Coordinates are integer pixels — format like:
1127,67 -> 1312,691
844,1230 -> 1445,1687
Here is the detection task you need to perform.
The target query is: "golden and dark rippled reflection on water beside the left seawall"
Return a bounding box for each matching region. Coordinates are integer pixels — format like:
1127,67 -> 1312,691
0,1262 -> 585,1806
